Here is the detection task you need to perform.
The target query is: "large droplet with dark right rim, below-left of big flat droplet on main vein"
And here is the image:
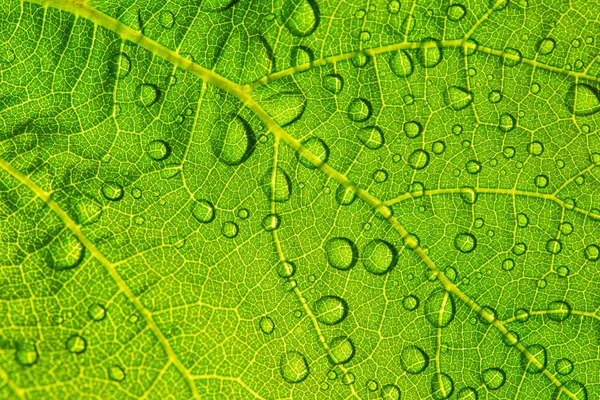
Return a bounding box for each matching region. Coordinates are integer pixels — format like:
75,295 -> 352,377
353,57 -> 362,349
211,115 -> 256,166
